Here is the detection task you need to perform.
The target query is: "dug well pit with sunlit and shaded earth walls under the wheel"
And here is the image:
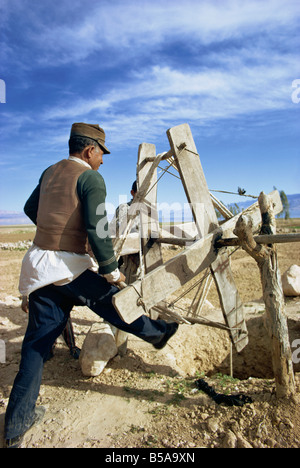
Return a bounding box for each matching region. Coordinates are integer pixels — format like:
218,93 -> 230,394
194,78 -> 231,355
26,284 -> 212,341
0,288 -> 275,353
152,315 -> 300,380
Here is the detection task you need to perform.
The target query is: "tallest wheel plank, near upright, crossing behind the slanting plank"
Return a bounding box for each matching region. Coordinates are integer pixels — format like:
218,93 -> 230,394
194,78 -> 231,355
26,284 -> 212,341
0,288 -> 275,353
167,124 -> 249,352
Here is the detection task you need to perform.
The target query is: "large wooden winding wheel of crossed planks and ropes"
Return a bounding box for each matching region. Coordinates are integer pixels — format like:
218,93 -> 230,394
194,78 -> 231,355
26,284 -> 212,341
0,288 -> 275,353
113,124 -> 282,352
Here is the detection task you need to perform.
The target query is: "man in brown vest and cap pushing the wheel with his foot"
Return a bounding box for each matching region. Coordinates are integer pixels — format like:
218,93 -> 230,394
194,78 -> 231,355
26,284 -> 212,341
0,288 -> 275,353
5,123 -> 178,448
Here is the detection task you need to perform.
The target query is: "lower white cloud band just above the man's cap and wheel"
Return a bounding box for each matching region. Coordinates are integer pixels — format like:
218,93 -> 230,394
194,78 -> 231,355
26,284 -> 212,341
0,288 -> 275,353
45,49 -> 297,131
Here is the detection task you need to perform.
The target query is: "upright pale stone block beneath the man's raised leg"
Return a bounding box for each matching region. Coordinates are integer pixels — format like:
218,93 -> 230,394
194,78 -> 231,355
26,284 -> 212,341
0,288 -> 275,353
79,323 -> 118,377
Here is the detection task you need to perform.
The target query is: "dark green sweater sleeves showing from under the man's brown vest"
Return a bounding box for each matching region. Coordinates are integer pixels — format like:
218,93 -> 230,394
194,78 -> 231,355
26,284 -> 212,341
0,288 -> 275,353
24,165 -> 118,274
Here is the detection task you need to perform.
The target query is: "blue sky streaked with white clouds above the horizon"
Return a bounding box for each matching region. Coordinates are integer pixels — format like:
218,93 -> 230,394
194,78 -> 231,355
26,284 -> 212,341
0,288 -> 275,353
0,0 -> 300,216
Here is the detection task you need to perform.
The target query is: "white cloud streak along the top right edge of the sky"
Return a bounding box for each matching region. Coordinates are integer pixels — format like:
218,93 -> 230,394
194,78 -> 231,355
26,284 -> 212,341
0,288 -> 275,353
72,0 -> 300,49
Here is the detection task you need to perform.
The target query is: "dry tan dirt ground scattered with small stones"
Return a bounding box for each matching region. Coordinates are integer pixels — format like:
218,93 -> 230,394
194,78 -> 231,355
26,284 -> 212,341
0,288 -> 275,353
0,220 -> 300,449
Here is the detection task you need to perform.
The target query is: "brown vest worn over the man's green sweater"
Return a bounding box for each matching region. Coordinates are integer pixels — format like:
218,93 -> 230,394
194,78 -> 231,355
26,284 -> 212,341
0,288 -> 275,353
33,159 -> 92,254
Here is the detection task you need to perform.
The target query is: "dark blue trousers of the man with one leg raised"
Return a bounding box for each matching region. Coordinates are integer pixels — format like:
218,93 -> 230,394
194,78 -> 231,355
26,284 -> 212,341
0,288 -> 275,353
5,270 -> 166,439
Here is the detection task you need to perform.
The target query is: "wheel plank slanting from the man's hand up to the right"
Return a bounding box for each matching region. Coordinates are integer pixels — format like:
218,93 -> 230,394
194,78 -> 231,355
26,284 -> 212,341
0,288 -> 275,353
113,191 -> 282,323
